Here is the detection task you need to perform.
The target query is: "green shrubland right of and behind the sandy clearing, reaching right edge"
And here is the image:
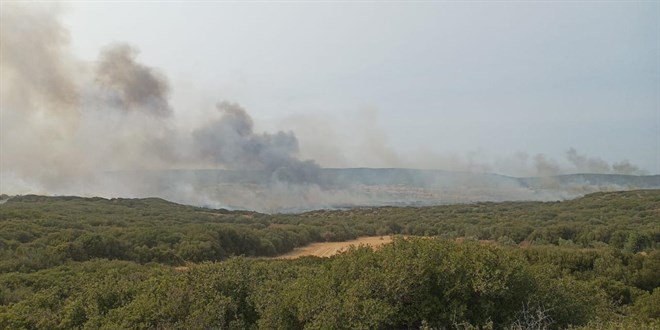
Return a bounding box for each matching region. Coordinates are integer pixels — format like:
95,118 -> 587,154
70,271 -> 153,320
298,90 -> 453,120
287,190 -> 660,252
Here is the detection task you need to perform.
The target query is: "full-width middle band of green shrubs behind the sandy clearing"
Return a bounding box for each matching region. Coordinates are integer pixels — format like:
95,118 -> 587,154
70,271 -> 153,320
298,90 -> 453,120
0,190 -> 660,272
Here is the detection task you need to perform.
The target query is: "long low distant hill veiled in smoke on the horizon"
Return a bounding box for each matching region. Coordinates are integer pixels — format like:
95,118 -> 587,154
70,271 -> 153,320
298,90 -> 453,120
91,168 -> 660,213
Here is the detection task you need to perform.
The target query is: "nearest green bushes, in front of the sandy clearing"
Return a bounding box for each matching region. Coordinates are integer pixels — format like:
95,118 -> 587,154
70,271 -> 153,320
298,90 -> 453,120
0,239 -> 660,329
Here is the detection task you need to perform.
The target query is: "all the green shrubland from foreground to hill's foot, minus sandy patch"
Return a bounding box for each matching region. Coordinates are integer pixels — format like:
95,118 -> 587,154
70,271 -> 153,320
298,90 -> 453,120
0,190 -> 660,329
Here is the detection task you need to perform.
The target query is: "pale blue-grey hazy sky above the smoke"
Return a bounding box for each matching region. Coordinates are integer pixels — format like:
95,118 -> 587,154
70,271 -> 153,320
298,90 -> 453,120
40,1 -> 660,173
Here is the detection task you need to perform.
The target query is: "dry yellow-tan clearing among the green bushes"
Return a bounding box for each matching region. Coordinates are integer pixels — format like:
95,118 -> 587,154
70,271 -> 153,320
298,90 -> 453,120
276,236 -> 392,259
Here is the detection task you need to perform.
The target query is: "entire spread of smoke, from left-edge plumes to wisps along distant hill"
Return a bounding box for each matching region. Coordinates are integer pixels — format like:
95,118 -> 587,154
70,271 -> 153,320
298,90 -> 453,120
0,3 -> 652,211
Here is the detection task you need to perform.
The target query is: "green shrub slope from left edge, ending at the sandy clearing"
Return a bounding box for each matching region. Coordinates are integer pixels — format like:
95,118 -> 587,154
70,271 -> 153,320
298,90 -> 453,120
0,196 -> 322,272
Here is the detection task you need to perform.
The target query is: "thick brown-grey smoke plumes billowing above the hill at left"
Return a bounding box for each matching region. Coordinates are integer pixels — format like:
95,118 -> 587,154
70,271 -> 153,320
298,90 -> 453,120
0,3 -> 319,193
